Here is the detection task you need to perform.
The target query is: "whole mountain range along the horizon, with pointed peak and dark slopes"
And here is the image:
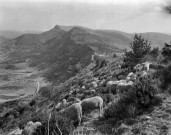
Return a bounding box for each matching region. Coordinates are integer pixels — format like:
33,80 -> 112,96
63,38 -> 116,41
0,25 -> 171,81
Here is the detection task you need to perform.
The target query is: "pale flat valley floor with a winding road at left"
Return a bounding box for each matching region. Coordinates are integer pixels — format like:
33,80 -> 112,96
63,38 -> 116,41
0,62 -> 47,103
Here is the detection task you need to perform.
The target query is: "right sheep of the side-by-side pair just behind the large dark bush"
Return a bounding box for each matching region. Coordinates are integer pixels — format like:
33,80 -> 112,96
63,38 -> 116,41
116,81 -> 133,95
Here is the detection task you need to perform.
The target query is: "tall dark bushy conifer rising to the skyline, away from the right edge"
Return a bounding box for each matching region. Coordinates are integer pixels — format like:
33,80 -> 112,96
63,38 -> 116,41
124,34 -> 151,67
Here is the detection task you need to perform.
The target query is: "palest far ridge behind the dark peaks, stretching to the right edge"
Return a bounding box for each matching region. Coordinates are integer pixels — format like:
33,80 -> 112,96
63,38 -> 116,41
55,26 -> 171,49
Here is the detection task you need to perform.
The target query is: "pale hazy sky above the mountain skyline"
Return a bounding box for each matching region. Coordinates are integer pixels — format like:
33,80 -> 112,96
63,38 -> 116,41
0,0 -> 171,33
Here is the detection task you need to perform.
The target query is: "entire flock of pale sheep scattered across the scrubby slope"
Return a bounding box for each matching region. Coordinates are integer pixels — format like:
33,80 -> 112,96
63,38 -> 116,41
23,62 -> 164,135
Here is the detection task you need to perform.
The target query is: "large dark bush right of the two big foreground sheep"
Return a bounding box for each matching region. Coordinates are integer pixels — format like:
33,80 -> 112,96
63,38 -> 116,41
104,79 -> 156,120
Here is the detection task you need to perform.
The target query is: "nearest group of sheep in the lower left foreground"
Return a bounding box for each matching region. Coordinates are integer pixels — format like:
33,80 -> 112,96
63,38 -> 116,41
22,96 -> 103,135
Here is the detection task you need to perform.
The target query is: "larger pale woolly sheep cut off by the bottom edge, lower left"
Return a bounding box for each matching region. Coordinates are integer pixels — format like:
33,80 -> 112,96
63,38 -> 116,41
22,121 -> 41,135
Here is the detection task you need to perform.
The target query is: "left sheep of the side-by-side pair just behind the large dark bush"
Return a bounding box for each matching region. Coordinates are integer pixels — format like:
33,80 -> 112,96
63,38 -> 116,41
107,80 -> 126,94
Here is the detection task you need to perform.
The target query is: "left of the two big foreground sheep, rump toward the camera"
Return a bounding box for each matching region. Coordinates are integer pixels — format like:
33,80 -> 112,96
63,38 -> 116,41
57,103 -> 82,126
